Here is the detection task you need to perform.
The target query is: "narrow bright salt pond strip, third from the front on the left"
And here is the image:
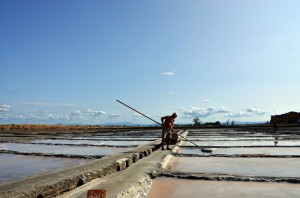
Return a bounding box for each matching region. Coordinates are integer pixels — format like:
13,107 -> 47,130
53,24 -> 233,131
31,138 -> 150,147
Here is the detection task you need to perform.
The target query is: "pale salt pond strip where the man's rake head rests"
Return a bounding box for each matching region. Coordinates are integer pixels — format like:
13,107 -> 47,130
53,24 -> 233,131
176,147 -> 300,157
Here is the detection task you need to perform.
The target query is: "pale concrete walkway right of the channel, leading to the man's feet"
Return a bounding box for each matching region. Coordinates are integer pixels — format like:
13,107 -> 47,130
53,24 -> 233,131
60,146 -> 170,198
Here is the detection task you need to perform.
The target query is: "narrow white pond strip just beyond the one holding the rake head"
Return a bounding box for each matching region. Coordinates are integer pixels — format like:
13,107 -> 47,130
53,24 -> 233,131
182,138 -> 300,147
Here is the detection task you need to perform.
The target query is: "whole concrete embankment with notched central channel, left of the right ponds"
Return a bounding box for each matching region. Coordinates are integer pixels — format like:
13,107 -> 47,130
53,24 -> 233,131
0,140 -> 170,198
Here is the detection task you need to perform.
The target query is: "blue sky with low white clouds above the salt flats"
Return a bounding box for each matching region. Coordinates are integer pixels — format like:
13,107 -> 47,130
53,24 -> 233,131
0,0 -> 300,125
